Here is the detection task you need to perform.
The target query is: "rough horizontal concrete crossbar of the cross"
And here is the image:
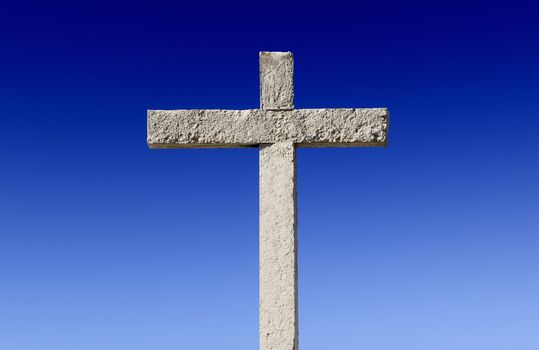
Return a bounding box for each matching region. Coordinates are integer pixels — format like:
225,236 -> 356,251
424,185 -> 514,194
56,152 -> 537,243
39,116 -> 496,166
147,108 -> 389,148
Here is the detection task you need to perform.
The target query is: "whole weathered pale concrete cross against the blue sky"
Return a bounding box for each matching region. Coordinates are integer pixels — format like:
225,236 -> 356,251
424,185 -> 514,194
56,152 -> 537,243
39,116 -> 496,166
147,52 -> 389,350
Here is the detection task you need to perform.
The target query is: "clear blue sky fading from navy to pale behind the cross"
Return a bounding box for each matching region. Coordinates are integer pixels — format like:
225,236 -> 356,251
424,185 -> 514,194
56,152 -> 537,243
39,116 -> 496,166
0,0 -> 539,350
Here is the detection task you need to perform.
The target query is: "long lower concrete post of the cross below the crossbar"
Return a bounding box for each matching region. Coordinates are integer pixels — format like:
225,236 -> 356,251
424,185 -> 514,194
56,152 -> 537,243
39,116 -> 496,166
260,142 -> 298,350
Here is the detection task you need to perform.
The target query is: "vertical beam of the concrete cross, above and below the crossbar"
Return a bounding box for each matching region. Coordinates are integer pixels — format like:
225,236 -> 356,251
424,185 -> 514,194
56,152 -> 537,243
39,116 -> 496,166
259,52 -> 298,350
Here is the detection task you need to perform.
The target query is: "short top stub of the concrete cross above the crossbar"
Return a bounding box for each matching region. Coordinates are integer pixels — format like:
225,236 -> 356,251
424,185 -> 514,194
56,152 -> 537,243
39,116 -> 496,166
259,52 -> 294,110
